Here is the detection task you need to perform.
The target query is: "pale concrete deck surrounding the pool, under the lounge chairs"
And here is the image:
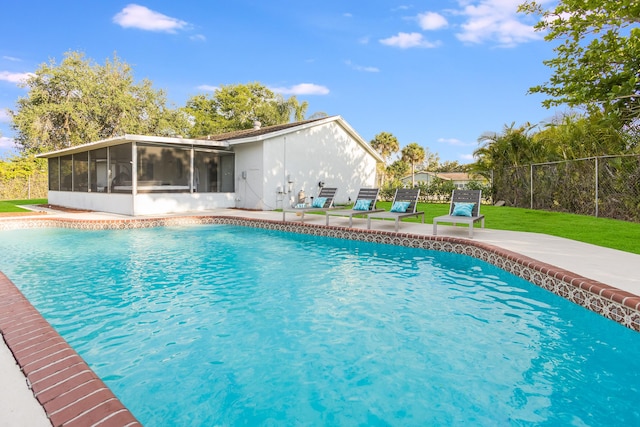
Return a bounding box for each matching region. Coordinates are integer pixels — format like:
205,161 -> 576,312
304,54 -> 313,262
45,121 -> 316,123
0,209 -> 640,426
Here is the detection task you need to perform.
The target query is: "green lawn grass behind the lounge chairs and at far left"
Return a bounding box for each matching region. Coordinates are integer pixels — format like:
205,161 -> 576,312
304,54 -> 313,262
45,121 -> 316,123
0,199 -> 640,255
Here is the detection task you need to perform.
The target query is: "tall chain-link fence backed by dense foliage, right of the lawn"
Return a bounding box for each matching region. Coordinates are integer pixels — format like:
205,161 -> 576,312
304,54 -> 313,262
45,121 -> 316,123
493,155 -> 640,222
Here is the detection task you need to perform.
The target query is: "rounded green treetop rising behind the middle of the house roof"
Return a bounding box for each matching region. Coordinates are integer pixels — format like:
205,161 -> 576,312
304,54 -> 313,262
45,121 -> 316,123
183,82 -> 308,137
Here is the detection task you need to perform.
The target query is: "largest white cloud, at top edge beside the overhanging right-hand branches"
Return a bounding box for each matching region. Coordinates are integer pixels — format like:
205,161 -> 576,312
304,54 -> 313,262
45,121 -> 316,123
456,0 -> 543,47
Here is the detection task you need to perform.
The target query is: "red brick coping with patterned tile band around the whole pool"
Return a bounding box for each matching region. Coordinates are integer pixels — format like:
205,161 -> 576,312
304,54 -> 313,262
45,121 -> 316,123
0,216 -> 640,426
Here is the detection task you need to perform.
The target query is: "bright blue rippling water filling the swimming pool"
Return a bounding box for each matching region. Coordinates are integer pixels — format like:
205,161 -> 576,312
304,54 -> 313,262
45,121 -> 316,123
0,225 -> 640,426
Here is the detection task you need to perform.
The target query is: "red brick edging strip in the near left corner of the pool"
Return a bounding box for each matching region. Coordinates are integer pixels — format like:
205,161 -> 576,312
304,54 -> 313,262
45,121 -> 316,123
0,272 -> 141,427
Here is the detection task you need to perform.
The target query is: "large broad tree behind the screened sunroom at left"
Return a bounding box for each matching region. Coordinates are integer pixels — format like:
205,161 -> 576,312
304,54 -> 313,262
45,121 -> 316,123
9,51 -> 189,152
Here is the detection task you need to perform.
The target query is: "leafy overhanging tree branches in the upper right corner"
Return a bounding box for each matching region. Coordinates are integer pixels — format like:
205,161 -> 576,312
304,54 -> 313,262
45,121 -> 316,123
519,0 -> 640,123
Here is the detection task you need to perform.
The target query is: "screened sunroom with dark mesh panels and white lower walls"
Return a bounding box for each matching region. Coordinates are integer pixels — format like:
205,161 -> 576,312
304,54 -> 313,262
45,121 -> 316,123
40,135 -> 235,215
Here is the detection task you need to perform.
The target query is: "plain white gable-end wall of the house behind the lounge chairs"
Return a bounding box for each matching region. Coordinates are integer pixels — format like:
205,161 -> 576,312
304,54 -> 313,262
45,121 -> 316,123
260,121 -> 376,208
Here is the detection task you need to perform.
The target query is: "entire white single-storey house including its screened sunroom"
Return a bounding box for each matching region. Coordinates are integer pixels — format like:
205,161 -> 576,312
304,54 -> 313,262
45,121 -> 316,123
40,116 -> 383,216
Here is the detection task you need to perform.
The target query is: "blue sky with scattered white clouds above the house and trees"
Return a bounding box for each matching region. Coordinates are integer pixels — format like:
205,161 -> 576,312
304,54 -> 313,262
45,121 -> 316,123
0,0 -> 556,163
